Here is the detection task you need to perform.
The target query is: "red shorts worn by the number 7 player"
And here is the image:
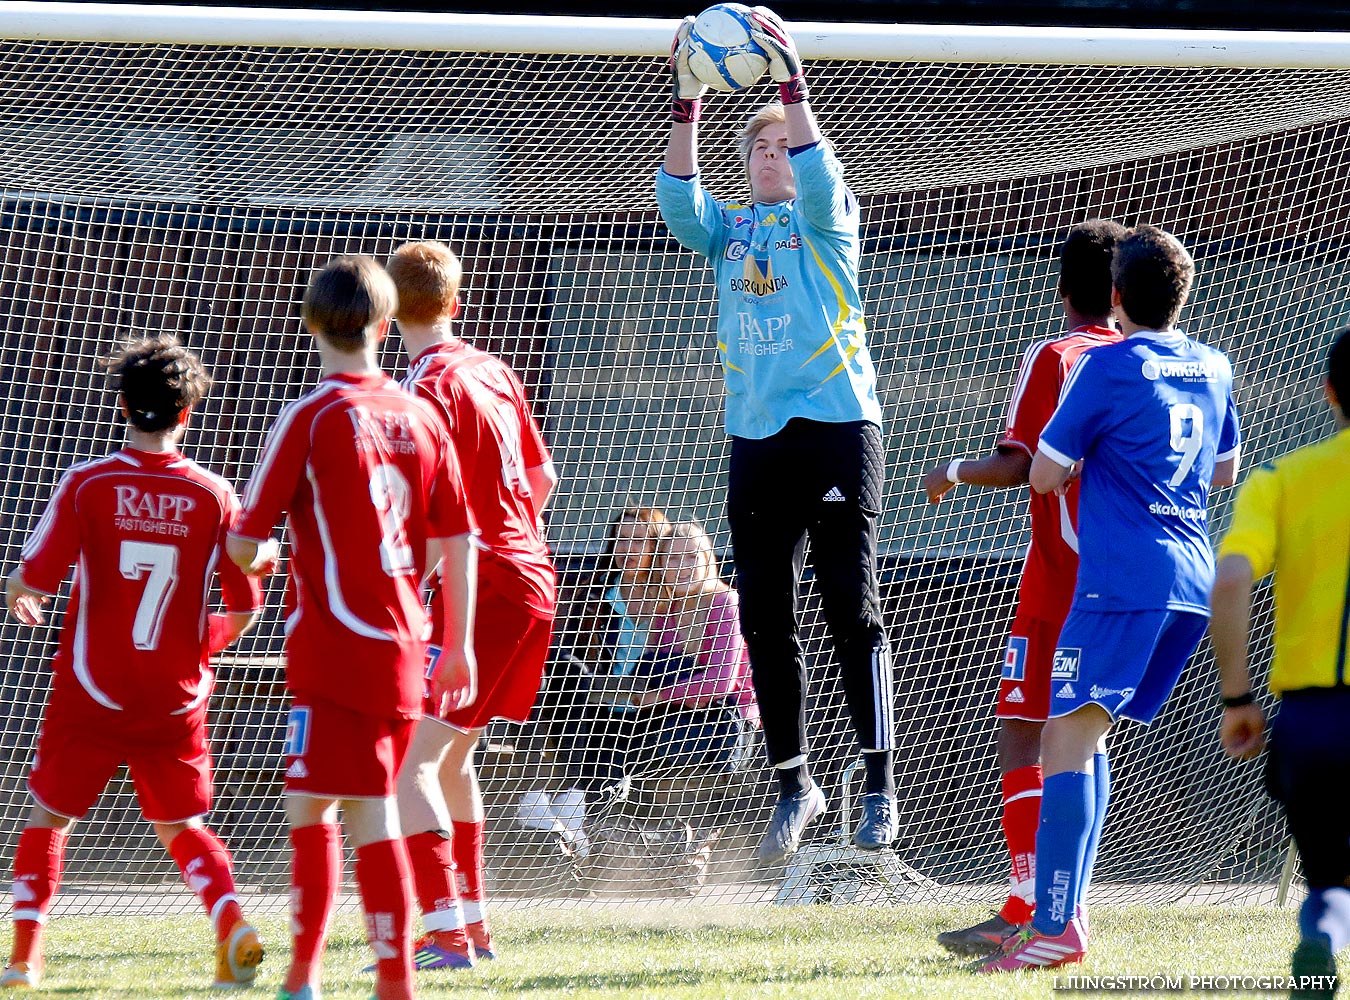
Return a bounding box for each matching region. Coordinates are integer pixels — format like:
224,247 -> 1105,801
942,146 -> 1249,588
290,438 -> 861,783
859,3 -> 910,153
28,698 -> 211,823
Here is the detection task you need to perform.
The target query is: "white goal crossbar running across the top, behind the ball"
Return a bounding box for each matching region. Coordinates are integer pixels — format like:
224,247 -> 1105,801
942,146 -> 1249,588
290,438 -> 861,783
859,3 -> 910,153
0,0 -> 1350,69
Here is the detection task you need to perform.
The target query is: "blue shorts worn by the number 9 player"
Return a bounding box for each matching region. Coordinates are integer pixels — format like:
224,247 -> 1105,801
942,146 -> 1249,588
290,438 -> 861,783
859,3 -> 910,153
1050,609 -> 1210,723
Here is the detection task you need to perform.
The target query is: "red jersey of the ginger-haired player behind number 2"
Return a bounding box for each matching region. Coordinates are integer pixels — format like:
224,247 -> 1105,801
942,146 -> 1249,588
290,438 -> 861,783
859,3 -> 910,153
404,340 -> 556,617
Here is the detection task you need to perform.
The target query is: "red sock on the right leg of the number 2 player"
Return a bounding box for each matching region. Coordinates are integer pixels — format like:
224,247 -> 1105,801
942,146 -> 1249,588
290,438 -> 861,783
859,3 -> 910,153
356,839 -> 413,1000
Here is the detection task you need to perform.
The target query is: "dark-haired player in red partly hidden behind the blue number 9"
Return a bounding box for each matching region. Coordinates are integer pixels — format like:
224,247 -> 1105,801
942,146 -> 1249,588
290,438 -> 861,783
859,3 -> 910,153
923,219 -> 1126,954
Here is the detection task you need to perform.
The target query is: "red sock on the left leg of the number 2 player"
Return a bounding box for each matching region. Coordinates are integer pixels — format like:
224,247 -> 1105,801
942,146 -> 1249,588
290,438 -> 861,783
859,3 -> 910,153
284,823 -> 342,992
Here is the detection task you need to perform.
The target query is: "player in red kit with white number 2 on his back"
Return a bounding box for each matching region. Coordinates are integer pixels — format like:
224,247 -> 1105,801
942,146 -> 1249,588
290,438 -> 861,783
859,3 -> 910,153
230,256 -> 475,1000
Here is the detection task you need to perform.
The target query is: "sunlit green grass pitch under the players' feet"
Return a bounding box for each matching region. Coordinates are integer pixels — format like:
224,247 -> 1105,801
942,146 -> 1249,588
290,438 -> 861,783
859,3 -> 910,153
18,906 -> 1295,1000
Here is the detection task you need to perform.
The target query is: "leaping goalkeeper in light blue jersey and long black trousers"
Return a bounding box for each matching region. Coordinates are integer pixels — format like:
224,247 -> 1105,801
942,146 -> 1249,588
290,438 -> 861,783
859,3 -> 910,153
656,7 -> 896,864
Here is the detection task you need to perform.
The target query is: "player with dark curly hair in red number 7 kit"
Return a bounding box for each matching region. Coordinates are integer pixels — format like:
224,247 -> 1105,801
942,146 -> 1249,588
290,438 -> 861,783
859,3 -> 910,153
0,336 -> 266,988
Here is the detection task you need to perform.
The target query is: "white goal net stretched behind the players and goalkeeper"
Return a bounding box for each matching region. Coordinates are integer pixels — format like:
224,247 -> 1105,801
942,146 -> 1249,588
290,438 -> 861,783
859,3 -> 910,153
0,4 -> 1350,912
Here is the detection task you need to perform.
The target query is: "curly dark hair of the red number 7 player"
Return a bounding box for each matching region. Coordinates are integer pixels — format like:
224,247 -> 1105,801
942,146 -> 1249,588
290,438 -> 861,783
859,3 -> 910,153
107,335 -> 211,433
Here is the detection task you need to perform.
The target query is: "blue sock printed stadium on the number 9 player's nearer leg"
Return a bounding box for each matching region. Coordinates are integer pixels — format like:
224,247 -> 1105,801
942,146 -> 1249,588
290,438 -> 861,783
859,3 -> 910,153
1031,771 -> 1096,937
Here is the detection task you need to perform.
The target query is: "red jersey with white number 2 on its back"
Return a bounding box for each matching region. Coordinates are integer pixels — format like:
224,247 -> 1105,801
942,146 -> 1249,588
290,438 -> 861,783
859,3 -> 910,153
234,374 -> 475,719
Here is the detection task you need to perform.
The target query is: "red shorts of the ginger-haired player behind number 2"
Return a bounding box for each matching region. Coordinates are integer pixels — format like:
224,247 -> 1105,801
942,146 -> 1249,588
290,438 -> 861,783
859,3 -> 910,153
424,577 -> 554,733
